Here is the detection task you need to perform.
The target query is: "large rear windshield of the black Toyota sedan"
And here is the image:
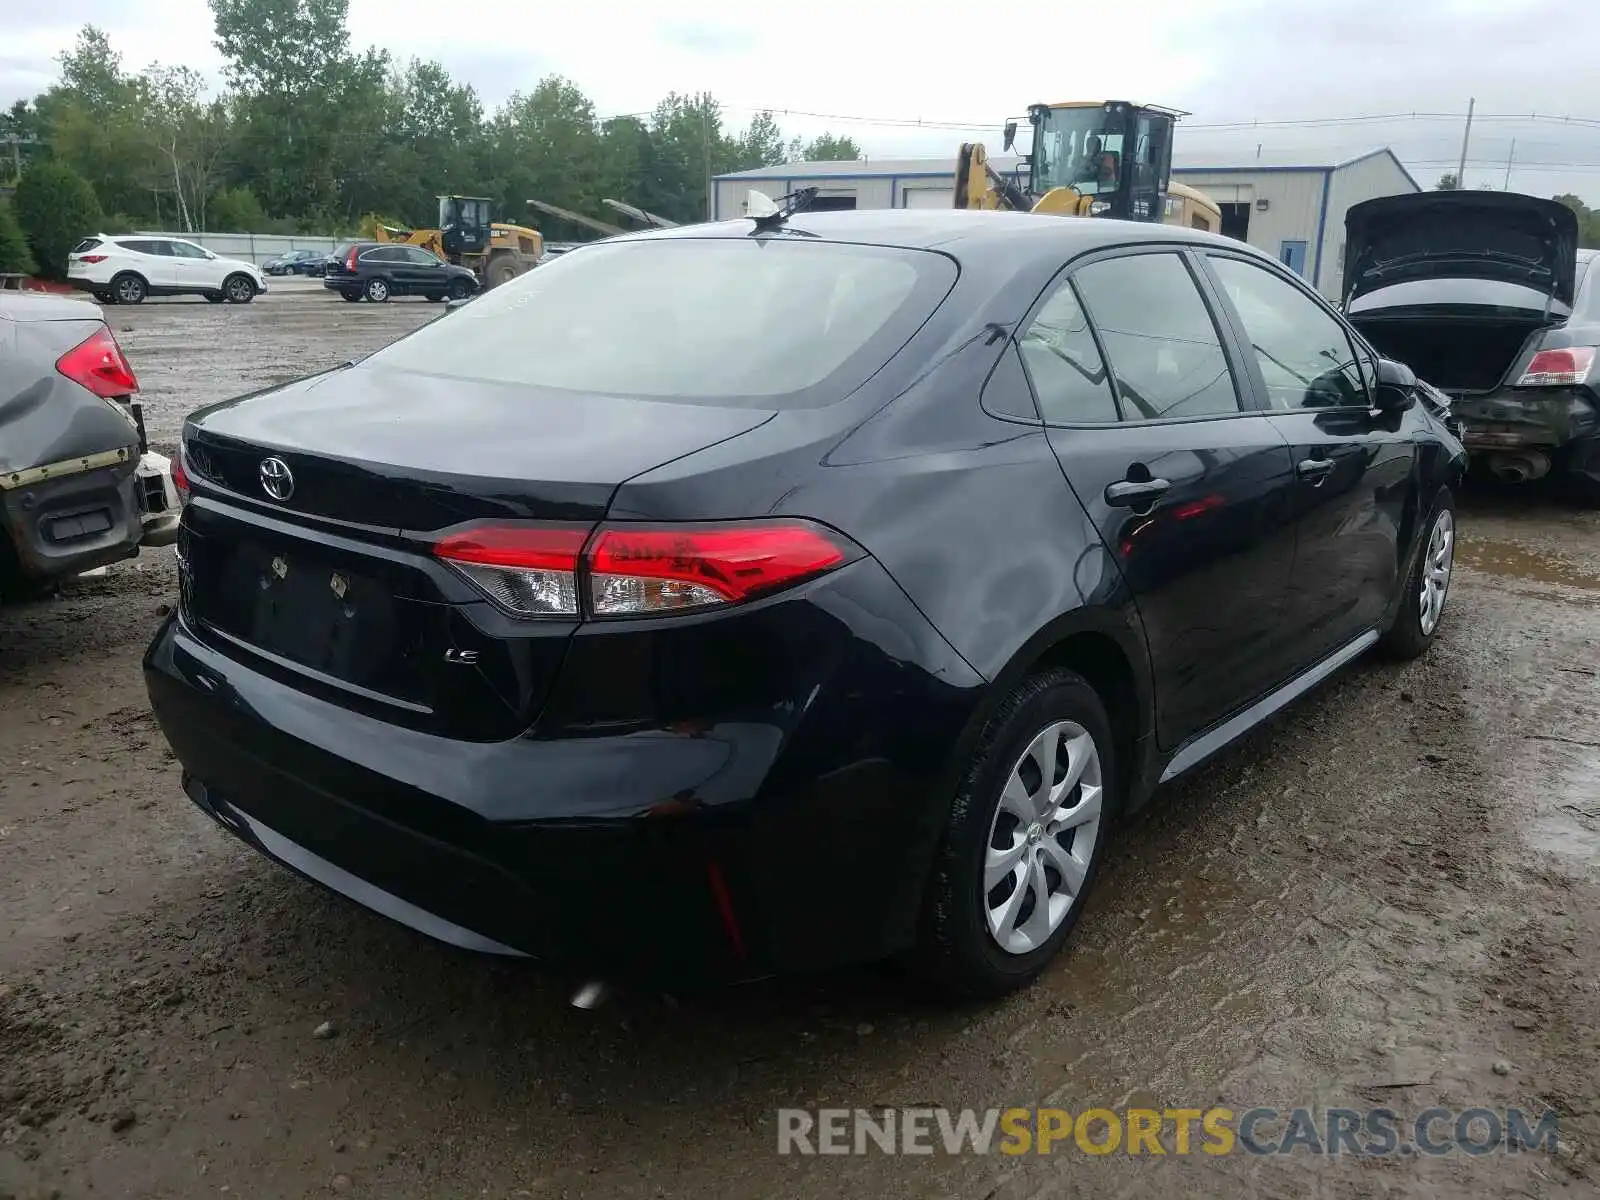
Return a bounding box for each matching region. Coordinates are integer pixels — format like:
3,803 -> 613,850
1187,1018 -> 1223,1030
365,237 -> 957,408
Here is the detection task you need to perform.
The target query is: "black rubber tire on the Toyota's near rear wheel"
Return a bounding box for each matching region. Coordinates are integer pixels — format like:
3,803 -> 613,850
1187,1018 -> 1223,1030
909,667 -> 1120,997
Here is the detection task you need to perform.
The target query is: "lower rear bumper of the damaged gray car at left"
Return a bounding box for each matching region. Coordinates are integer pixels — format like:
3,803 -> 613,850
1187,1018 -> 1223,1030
0,450 -> 144,581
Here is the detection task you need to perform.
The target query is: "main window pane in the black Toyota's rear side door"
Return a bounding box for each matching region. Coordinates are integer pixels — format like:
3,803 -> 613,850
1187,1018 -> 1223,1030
1072,254 -> 1238,421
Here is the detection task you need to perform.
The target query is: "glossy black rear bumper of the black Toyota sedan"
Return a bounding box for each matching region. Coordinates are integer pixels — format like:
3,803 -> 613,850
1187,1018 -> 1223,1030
144,562 -> 982,986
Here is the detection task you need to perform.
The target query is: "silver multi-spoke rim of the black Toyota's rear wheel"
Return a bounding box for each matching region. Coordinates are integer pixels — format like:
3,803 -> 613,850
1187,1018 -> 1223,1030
982,722 -> 1104,954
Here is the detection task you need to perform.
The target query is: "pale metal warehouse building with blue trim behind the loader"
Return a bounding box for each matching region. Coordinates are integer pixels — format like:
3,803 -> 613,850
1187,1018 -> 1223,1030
710,147 -> 1421,298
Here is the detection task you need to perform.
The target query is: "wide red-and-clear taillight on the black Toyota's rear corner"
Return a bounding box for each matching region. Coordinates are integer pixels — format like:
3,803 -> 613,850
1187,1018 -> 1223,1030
434,520 -> 862,618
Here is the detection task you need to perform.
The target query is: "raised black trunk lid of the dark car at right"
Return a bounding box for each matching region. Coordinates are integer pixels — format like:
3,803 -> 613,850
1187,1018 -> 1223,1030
1344,192 -> 1578,306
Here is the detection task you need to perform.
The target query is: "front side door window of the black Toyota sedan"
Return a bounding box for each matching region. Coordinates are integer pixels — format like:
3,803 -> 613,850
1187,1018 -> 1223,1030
1211,258 -> 1368,410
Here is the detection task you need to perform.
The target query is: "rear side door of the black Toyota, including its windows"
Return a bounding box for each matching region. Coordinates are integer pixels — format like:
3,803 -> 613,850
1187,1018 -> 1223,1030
1019,248 -> 1294,749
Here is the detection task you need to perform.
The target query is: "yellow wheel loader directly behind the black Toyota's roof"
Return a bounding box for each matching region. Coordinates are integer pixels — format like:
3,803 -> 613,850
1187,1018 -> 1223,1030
955,101 -> 1222,234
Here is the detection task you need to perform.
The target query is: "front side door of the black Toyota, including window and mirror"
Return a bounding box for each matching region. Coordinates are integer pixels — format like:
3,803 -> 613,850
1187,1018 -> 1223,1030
1205,251 -> 1416,658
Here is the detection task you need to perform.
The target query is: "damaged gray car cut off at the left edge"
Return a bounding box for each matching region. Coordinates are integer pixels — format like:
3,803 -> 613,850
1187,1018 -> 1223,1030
0,293 -> 179,598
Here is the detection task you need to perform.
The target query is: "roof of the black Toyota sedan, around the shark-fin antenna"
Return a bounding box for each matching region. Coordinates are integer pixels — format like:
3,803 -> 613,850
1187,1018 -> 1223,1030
611,208 -> 1241,258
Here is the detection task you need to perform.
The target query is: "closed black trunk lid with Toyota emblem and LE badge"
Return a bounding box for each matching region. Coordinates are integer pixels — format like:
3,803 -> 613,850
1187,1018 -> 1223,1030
179,366 -> 771,739
